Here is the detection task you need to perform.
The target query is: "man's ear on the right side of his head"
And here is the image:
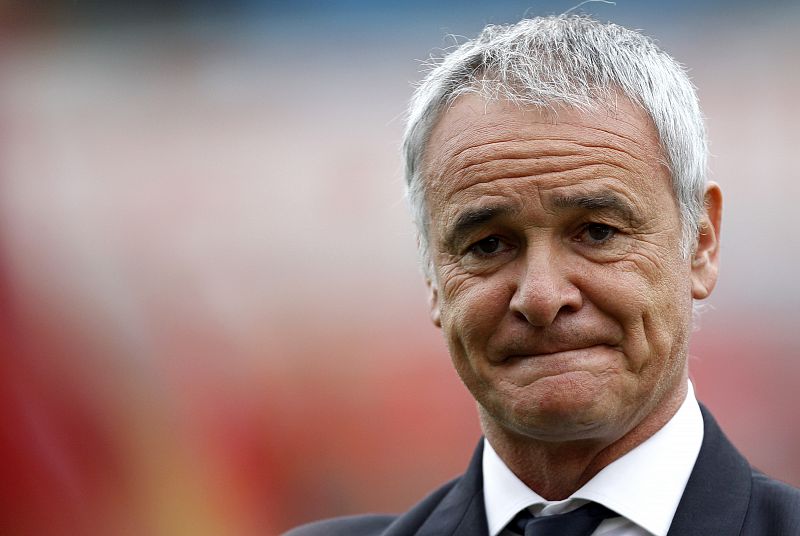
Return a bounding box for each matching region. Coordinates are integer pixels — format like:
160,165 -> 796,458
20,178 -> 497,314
692,182 -> 722,300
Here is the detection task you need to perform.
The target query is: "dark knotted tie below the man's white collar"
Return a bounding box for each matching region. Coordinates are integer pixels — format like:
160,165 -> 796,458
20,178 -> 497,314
508,503 -> 619,536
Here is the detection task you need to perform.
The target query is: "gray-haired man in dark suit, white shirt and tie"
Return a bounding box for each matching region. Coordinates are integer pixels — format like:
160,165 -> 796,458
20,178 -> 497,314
292,16 -> 800,536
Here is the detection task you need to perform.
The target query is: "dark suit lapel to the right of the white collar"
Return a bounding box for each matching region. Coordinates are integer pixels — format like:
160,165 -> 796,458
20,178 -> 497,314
668,404 -> 751,536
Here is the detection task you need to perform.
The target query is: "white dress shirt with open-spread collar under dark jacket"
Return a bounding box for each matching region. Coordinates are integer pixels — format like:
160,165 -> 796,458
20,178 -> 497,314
483,382 -> 703,536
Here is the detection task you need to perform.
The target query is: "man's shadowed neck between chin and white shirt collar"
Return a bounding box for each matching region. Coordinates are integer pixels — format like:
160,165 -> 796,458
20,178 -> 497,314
480,386 -> 686,501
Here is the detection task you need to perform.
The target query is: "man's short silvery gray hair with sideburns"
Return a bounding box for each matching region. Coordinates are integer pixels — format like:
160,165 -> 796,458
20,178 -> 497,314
403,15 -> 708,278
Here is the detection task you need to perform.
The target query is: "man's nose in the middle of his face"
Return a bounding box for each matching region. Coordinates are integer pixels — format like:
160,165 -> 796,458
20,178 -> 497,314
509,250 -> 583,327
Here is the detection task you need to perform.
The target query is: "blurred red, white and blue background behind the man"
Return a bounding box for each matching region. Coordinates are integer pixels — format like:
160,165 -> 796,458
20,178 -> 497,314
0,0 -> 800,536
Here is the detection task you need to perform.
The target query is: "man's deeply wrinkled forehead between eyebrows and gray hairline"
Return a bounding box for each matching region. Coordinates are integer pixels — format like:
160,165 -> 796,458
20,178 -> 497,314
423,95 -> 671,220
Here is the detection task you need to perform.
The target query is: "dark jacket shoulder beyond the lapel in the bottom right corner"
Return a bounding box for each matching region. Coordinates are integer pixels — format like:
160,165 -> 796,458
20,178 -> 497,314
742,471 -> 800,534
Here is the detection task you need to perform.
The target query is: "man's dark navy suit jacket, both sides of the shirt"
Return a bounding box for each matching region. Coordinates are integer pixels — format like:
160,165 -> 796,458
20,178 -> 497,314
287,406 -> 800,536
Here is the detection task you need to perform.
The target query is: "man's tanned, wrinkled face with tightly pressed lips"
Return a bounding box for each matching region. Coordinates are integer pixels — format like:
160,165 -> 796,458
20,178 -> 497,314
424,95 -> 719,441
